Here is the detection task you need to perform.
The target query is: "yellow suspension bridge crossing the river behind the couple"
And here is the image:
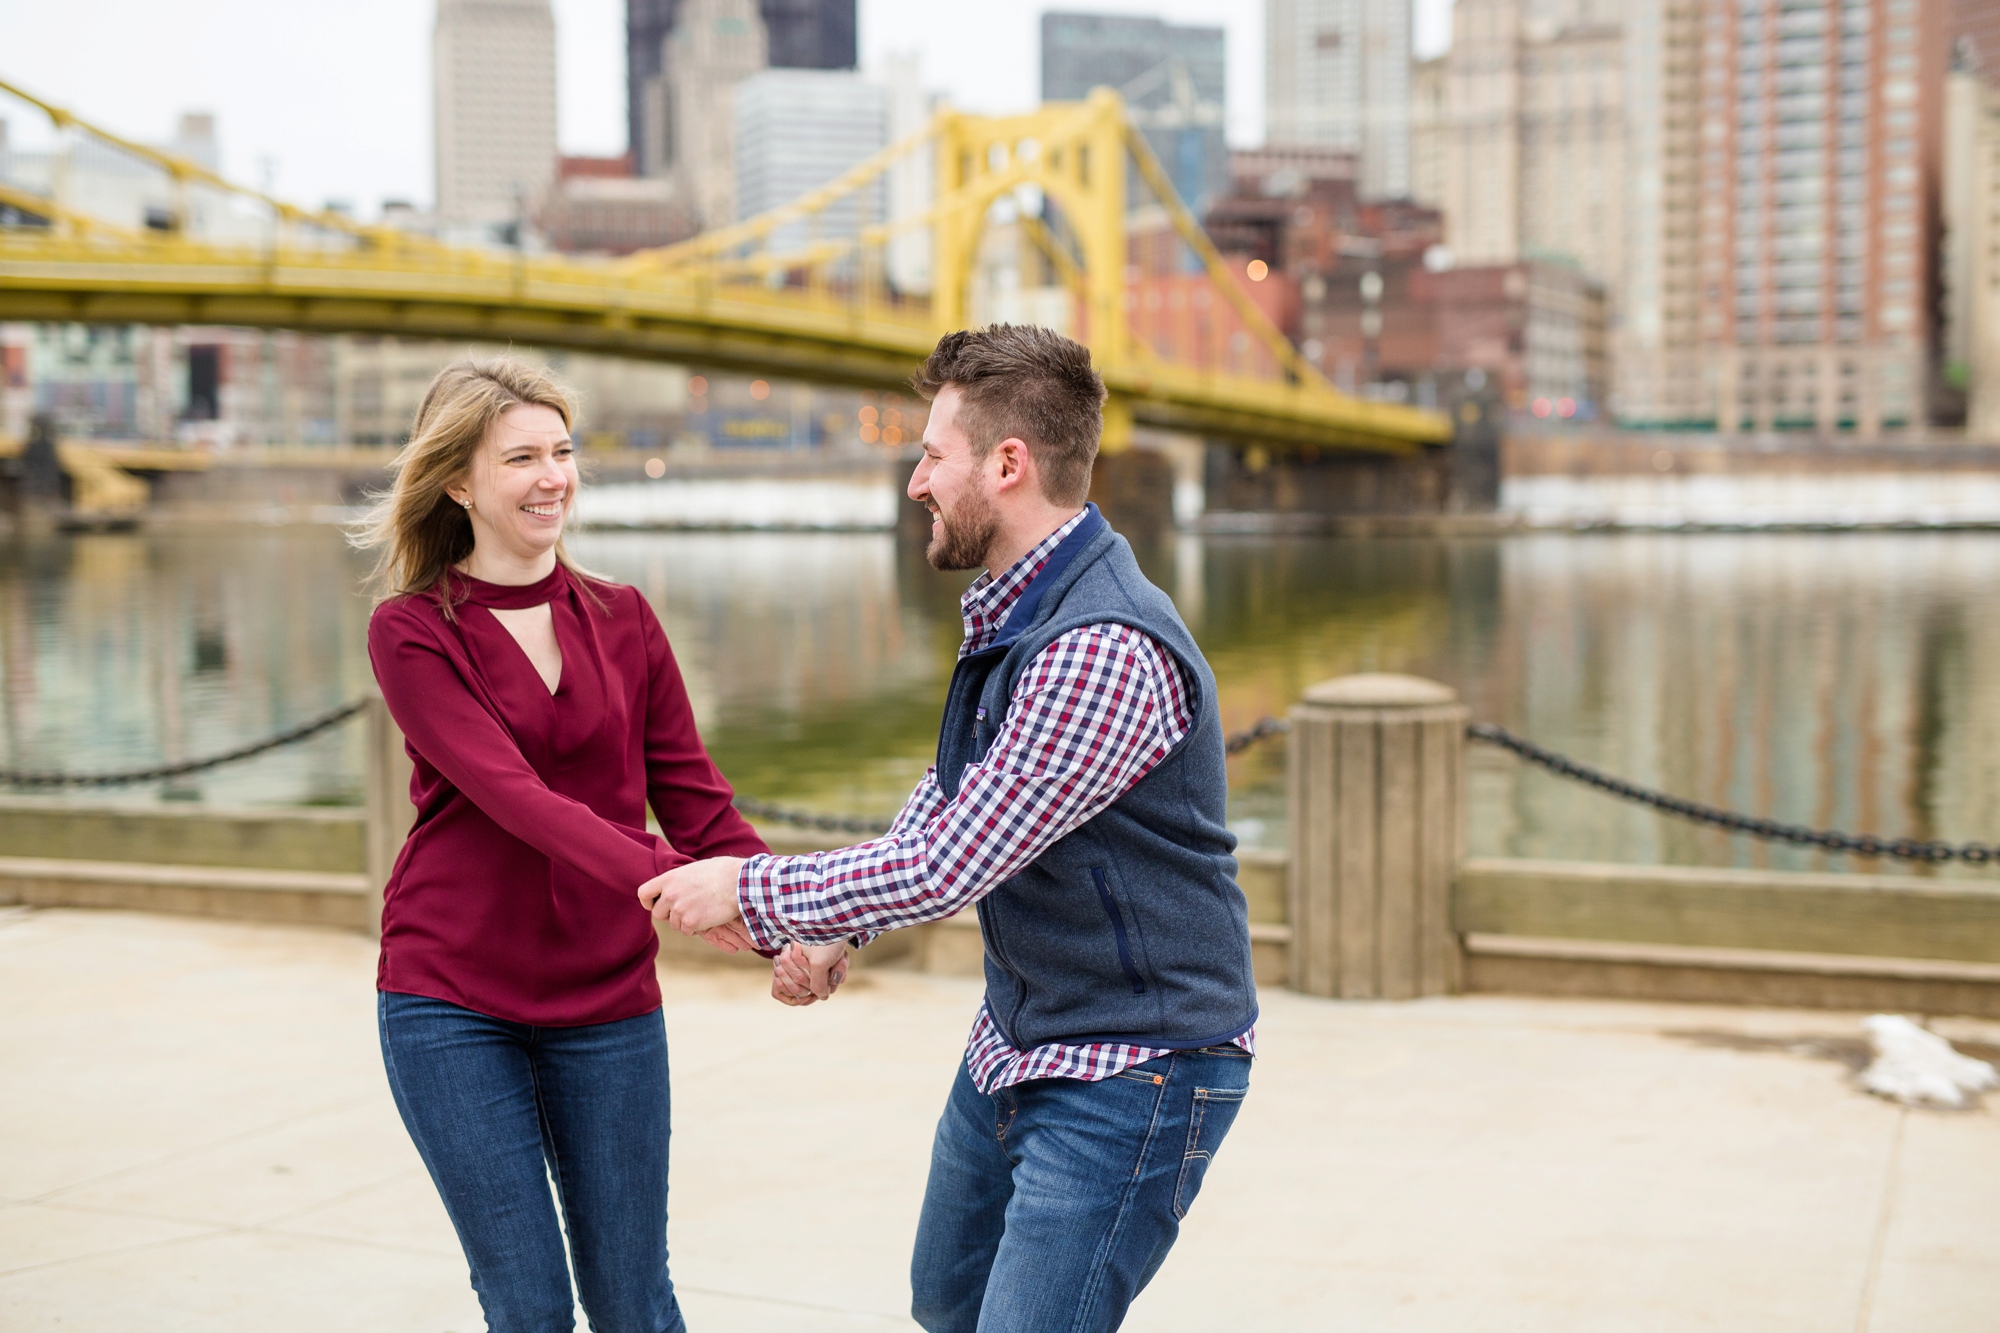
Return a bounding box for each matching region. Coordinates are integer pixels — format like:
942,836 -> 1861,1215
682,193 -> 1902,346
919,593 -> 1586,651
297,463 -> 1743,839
0,80 -> 1450,452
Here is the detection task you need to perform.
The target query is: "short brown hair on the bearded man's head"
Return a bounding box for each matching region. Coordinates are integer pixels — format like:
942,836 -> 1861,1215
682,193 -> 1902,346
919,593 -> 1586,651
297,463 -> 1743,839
912,324 -> 1104,504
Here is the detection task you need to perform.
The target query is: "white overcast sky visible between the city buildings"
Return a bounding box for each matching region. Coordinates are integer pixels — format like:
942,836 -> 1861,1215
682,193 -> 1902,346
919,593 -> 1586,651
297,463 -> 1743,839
0,0 -> 1450,216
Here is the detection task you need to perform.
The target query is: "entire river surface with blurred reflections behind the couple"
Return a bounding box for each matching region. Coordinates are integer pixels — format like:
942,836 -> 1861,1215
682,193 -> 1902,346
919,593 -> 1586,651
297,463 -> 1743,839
0,524 -> 2000,875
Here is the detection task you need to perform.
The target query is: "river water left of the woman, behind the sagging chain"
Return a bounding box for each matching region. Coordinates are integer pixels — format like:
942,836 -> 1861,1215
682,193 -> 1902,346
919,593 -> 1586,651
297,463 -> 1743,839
0,528 -> 368,805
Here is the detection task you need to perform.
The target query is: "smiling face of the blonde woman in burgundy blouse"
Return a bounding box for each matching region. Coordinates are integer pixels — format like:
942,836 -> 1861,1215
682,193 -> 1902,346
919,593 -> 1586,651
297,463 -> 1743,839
450,402 -> 576,560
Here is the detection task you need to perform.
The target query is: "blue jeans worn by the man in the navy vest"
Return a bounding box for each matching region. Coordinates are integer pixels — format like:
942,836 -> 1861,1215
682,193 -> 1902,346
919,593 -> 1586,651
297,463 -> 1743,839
910,1047 -> 1250,1333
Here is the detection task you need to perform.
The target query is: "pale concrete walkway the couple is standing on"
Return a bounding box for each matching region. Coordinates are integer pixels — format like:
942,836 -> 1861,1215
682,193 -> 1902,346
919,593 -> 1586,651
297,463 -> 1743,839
0,911 -> 2000,1333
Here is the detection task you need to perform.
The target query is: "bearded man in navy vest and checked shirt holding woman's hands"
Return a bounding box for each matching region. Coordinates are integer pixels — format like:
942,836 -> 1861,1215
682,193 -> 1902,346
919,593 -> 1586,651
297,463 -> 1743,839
640,324 -> 1256,1333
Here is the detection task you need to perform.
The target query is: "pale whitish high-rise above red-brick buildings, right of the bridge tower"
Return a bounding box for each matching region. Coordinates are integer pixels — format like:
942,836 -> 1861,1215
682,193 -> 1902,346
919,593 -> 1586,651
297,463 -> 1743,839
1264,0 -> 1410,198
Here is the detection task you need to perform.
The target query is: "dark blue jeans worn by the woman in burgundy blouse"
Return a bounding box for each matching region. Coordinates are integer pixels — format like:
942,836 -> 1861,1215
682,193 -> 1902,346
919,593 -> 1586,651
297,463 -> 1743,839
378,993 -> 684,1333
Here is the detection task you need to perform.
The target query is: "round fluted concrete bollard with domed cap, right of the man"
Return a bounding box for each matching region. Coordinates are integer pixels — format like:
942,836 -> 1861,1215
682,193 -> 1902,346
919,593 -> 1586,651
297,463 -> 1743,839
1286,675 -> 1468,999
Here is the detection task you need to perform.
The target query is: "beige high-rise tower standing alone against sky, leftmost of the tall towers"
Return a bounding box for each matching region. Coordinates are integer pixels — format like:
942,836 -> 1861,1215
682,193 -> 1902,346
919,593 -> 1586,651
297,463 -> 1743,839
432,0 -> 556,228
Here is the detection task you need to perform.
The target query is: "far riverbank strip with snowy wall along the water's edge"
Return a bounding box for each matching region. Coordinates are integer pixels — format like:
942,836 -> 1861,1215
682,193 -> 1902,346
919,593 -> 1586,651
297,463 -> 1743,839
19,432 -> 2000,536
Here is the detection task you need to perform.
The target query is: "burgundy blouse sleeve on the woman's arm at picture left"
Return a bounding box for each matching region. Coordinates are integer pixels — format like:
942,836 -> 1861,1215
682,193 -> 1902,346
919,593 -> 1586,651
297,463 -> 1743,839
368,602 -> 684,897
